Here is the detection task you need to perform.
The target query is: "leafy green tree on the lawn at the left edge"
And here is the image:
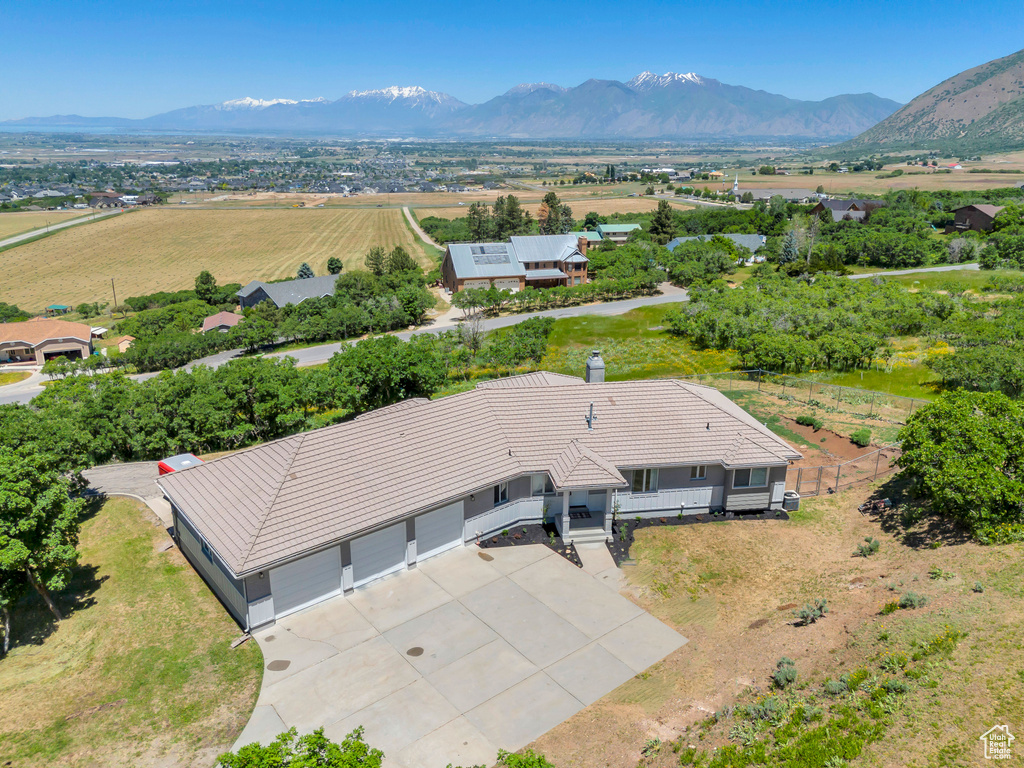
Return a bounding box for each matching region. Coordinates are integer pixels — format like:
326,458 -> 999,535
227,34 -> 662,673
0,446 -> 85,634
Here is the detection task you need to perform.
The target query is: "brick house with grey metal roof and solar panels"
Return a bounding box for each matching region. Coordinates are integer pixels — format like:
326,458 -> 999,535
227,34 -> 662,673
441,234 -> 589,293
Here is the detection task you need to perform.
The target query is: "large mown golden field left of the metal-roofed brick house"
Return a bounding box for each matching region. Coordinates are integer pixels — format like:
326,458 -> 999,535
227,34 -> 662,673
0,207 -> 429,311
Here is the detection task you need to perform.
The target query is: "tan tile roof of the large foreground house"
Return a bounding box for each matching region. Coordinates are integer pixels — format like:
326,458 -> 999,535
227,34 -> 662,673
160,374 -> 800,574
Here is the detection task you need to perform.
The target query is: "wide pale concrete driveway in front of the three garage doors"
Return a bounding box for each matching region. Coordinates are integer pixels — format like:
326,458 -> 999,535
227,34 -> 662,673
236,545 -> 686,768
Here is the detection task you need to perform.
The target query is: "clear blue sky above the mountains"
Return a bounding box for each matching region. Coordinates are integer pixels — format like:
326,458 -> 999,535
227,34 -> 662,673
0,0 -> 1024,120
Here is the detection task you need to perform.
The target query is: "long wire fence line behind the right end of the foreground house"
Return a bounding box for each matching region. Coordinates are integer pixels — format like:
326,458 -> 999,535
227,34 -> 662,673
682,369 -> 928,424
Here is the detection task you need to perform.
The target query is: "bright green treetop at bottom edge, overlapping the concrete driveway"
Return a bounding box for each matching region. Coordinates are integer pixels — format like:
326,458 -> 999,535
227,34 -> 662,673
217,727 -> 384,768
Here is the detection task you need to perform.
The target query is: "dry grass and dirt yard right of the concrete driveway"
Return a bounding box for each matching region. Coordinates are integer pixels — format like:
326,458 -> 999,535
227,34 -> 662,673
534,481 -> 1024,768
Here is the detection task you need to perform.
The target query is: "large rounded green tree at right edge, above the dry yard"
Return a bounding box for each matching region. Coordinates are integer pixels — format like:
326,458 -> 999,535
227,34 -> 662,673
896,390 -> 1024,532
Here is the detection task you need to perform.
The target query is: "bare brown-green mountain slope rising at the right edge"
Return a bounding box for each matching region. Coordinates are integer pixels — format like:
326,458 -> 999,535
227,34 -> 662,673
836,50 -> 1024,154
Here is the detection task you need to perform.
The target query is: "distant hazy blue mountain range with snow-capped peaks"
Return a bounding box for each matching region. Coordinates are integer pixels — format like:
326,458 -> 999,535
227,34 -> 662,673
0,72 -> 900,141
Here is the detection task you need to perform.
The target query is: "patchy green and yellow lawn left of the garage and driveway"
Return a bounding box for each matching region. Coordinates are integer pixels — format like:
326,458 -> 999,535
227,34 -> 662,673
0,499 -> 263,768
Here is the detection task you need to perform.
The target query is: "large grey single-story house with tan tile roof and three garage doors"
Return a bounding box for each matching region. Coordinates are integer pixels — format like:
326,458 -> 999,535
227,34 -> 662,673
158,353 -> 800,629
